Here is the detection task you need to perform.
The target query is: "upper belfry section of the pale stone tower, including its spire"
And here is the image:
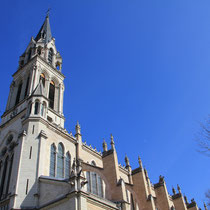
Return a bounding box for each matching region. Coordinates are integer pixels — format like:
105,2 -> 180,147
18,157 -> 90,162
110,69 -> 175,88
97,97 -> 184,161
2,15 -> 64,128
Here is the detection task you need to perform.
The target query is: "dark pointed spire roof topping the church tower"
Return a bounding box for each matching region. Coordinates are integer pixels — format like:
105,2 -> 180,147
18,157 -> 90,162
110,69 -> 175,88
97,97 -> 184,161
35,14 -> 52,44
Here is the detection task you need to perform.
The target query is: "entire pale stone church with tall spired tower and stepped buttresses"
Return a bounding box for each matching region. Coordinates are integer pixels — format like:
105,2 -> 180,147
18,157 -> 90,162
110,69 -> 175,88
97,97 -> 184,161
0,15 -> 207,210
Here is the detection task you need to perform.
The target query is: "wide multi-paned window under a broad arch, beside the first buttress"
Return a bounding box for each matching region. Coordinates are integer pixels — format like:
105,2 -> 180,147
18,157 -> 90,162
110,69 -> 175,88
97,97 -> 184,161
86,171 -> 103,197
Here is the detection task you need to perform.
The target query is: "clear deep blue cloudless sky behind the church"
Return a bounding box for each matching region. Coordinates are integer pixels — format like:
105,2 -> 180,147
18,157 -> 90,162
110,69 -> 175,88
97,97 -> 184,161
0,0 -> 210,209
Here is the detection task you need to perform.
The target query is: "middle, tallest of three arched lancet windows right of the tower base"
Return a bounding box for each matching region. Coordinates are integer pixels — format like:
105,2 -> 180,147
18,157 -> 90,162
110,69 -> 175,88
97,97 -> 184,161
57,143 -> 64,178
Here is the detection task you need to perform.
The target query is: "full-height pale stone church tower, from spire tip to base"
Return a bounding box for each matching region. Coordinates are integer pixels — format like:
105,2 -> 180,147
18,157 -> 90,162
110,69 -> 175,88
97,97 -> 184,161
0,14 -> 67,209
